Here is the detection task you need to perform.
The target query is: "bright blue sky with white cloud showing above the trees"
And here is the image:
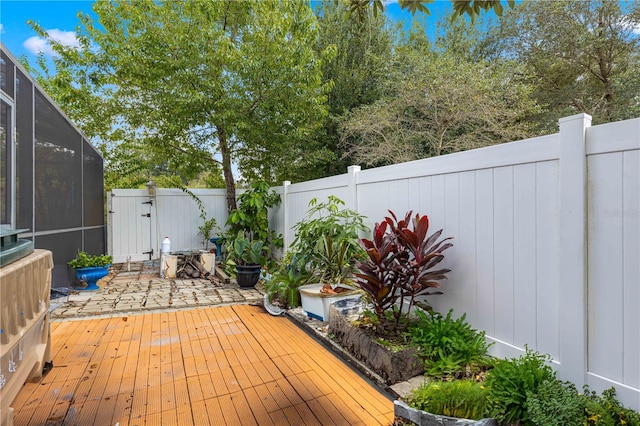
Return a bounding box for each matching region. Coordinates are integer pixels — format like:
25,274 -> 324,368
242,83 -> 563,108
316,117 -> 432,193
0,0 -> 451,61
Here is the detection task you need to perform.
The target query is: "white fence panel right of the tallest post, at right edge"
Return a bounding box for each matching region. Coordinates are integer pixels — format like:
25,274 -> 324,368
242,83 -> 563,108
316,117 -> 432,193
587,120 -> 640,409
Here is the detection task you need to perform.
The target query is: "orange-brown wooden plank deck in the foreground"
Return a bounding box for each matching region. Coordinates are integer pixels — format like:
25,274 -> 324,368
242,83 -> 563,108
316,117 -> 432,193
12,305 -> 393,426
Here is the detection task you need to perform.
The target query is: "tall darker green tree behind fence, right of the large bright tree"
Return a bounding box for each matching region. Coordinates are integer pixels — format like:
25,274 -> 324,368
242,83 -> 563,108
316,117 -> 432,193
298,0 -> 395,179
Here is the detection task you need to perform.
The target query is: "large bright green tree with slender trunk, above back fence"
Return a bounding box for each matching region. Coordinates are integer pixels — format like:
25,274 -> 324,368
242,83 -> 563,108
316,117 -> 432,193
27,0 -> 327,210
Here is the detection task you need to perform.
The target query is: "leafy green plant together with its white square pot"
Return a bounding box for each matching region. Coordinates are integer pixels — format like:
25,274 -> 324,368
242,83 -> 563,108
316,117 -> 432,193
291,196 -> 368,321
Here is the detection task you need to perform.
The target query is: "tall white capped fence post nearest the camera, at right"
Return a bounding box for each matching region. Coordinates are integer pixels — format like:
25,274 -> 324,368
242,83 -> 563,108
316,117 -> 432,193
558,113 -> 591,387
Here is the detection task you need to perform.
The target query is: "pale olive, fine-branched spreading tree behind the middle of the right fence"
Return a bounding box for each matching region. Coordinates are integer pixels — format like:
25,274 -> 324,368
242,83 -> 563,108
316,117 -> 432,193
342,19 -> 536,166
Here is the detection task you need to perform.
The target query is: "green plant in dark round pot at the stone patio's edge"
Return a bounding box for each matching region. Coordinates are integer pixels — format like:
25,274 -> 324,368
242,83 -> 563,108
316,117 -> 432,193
227,231 -> 269,287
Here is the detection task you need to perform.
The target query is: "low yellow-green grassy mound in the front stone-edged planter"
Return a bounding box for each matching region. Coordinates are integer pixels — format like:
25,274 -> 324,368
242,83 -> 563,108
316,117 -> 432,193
407,380 -> 487,420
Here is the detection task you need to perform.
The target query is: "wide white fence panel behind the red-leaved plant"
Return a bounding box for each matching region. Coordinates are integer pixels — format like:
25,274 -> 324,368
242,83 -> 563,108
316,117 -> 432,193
357,135 -> 559,358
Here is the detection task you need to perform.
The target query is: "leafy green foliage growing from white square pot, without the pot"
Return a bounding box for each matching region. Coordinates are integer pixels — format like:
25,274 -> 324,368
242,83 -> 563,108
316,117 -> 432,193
290,195 -> 367,284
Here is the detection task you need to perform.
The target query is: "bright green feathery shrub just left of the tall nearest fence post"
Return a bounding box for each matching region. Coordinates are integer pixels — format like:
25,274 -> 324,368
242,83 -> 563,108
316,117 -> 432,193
486,348 -> 556,425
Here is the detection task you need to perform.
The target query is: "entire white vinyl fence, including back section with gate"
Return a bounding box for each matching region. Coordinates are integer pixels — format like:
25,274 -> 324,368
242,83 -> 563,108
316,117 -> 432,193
110,114 -> 640,410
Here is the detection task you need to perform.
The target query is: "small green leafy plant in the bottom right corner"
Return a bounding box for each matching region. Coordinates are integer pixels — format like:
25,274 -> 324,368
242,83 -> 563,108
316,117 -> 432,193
583,386 -> 640,426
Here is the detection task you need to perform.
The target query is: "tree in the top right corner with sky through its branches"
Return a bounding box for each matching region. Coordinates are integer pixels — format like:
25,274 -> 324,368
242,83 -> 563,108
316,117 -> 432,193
487,0 -> 640,132
